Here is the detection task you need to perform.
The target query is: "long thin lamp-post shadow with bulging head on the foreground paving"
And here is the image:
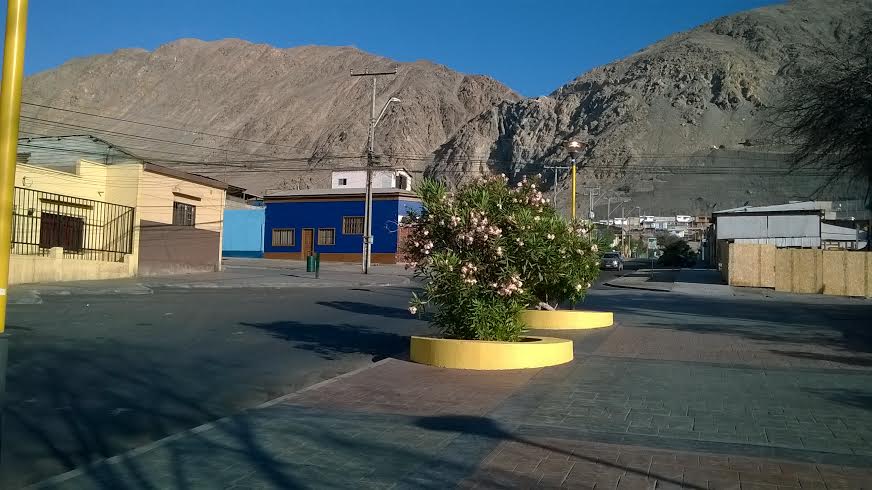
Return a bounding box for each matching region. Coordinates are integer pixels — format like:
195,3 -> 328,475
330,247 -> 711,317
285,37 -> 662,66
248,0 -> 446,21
415,415 -> 702,490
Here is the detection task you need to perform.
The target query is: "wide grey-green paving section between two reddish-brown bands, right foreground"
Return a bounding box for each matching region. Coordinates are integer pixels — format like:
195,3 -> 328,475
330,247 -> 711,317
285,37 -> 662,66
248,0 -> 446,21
500,357 -> 872,454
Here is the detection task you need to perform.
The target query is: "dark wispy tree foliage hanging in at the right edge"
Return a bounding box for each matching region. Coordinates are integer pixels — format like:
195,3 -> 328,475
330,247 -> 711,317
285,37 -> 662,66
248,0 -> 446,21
770,22 -> 872,207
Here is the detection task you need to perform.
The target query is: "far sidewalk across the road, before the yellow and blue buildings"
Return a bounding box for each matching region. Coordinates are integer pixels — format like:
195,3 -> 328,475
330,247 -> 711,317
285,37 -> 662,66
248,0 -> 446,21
9,258 -> 412,304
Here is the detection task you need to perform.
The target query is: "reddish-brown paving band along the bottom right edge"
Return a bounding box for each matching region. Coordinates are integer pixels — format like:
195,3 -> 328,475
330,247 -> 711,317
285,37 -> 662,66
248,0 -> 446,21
461,438 -> 872,490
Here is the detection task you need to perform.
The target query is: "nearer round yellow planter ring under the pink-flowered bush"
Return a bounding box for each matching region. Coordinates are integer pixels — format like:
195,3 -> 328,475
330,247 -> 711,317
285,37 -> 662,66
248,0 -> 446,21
411,337 -> 572,370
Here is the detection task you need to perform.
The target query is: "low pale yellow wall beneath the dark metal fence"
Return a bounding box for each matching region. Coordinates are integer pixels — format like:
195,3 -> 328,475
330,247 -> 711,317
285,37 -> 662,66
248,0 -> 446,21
9,247 -> 134,284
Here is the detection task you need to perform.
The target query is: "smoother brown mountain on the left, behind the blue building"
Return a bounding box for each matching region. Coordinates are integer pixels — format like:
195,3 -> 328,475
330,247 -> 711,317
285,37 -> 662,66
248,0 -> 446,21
22,39 -> 519,192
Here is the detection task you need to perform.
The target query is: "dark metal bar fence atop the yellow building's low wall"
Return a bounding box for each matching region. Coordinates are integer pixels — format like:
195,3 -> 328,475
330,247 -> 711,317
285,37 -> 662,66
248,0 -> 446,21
12,187 -> 134,262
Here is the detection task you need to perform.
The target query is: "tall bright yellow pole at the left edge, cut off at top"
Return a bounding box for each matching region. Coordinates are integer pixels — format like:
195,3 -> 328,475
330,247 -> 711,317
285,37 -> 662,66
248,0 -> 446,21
0,0 -> 28,334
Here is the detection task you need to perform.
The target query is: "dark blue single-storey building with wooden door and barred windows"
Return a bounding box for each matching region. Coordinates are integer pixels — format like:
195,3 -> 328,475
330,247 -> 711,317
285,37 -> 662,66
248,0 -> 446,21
264,189 -> 421,264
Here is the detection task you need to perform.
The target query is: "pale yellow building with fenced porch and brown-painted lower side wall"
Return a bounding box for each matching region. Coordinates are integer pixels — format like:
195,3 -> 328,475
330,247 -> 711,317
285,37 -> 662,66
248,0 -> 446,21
10,136 -> 227,284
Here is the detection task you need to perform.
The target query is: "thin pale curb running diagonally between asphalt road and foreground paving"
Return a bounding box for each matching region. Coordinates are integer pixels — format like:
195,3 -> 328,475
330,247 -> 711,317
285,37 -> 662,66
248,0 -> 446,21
22,357 -> 393,490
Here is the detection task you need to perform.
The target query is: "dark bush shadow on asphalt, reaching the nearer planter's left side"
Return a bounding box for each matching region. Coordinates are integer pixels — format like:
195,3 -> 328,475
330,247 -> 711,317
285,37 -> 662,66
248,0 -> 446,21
240,322 -> 409,359
